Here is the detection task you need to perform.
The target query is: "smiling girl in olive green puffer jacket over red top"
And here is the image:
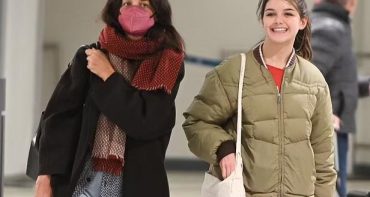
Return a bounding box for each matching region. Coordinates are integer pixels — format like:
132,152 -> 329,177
183,0 -> 336,197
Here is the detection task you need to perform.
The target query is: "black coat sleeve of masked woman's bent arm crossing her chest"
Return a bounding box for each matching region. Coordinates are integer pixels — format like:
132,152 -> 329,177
91,62 -> 184,140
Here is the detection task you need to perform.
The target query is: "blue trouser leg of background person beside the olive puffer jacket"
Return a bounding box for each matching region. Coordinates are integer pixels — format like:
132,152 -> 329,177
337,132 -> 348,197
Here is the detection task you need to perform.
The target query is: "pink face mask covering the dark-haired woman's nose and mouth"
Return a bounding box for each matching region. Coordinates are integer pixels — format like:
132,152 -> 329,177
118,6 -> 154,36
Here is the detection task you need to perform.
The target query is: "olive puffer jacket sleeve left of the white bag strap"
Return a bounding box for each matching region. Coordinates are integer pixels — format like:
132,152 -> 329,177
182,70 -> 235,164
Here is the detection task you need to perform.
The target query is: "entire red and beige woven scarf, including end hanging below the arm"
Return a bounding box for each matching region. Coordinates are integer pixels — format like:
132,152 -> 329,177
92,26 -> 184,176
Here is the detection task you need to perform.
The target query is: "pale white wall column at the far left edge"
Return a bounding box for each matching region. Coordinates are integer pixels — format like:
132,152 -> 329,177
4,0 -> 41,175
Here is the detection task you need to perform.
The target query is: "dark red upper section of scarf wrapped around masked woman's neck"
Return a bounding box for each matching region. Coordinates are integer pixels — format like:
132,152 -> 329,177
99,26 -> 184,94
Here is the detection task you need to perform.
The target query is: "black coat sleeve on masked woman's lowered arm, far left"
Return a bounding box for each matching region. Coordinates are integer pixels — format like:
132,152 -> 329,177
39,46 -> 90,175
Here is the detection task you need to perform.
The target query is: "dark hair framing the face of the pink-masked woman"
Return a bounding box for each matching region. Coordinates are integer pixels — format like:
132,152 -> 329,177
102,0 -> 184,51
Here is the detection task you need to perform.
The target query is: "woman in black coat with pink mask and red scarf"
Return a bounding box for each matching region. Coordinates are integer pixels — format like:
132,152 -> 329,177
36,0 -> 184,197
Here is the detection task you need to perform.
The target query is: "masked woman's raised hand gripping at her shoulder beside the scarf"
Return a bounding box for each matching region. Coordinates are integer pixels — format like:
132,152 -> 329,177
85,49 -> 114,81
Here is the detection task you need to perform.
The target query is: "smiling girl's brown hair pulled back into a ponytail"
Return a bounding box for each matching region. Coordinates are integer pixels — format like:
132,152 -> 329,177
257,0 -> 312,60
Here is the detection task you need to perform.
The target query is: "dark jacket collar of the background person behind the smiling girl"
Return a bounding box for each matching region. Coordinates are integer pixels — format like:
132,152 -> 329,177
312,2 -> 351,23
